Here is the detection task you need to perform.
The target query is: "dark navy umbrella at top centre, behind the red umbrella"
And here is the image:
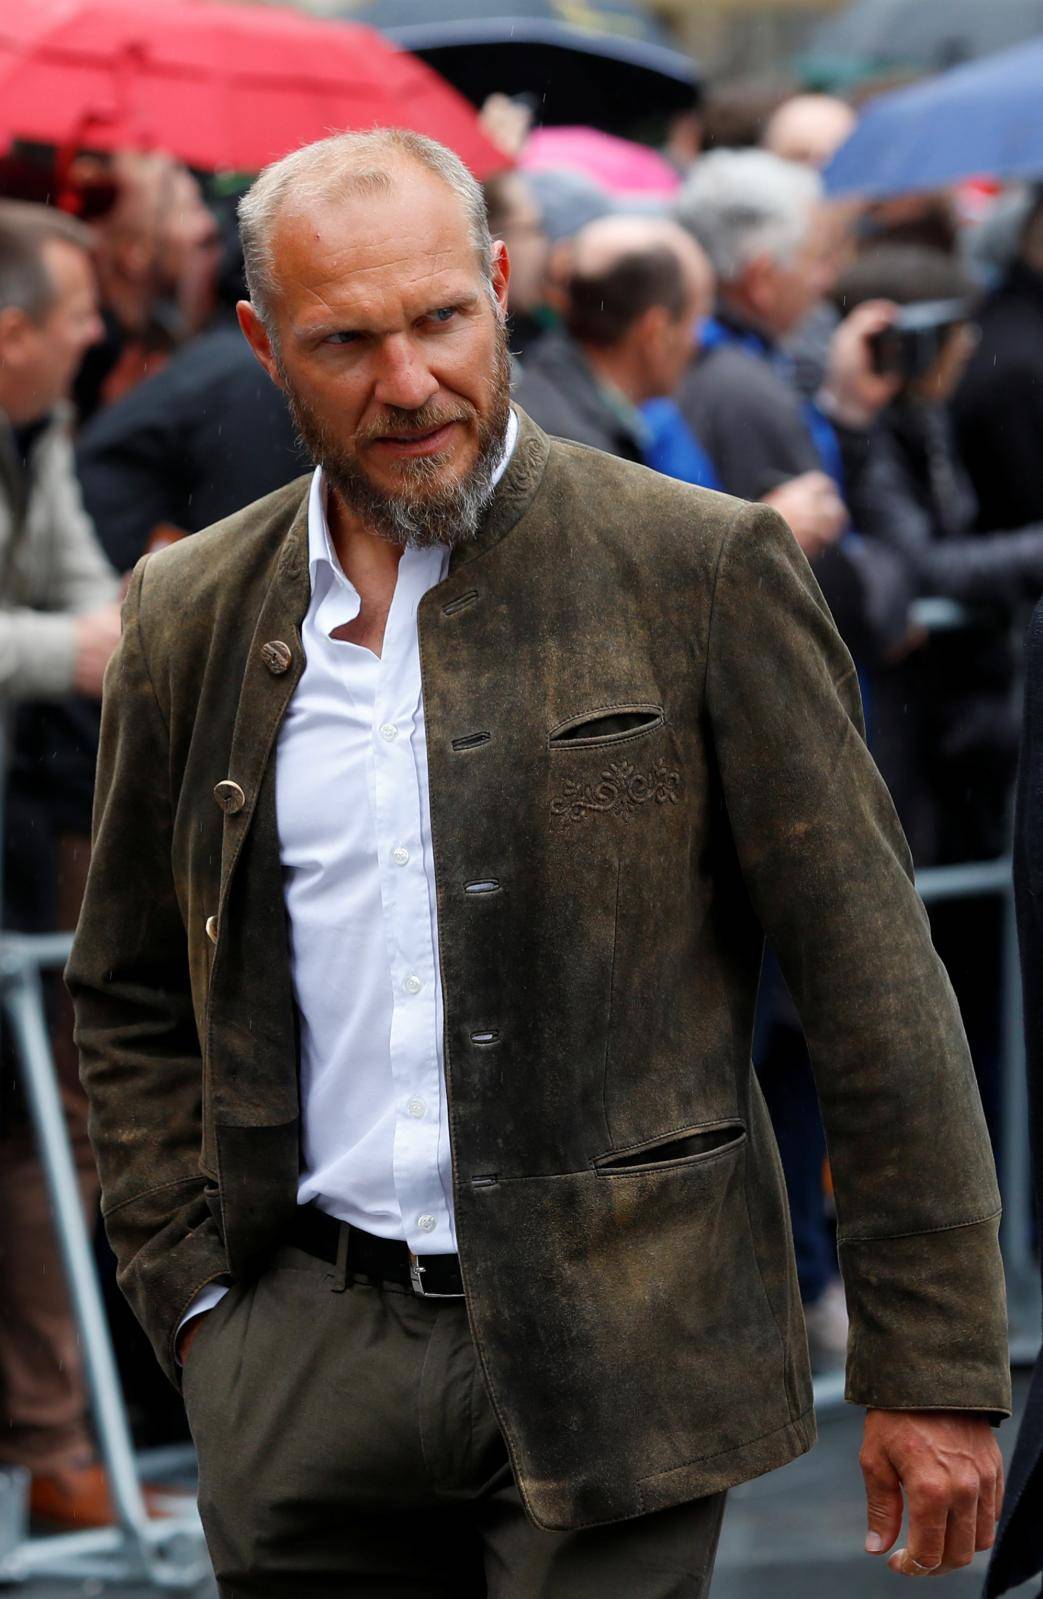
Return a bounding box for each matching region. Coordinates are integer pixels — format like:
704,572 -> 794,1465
342,0 -> 697,130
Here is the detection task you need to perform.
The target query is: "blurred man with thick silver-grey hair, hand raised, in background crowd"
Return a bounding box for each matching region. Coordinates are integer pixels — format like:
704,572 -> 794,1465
677,150 -> 910,662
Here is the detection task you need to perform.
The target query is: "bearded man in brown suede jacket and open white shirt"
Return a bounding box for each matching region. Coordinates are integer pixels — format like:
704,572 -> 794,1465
69,131 -> 1009,1599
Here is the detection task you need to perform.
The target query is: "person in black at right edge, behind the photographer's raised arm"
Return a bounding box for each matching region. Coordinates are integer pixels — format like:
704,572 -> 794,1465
953,190 -> 1043,531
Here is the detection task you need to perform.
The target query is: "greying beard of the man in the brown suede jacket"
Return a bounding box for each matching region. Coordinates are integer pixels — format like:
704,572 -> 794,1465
286,336 -> 510,550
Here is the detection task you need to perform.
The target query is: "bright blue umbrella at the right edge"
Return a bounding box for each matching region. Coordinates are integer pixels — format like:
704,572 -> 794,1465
824,38 -> 1043,200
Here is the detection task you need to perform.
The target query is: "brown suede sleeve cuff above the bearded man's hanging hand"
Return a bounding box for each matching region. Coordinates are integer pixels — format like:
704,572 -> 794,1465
840,1212 -> 1011,1417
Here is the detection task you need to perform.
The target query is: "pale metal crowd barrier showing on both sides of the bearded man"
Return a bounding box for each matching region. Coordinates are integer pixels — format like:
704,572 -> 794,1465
0,857 -> 1040,1567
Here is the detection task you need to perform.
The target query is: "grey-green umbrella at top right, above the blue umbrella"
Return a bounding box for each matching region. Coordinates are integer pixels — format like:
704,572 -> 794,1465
798,0 -> 1043,88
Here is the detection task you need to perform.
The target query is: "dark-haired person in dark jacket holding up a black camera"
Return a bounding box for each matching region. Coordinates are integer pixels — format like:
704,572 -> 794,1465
837,245 -> 1043,865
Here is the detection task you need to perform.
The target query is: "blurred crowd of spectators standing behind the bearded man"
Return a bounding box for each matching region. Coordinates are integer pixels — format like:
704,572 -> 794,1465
0,75 -> 1043,1525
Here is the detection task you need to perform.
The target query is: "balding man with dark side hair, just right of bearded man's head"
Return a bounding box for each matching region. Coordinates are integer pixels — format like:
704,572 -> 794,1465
515,216 -> 713,461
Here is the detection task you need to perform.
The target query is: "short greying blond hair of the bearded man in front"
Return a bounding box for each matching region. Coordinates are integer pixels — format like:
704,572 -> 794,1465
238,128 -> 493,331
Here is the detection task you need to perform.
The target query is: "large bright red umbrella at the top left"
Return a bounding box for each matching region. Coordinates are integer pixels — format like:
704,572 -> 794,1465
0,0 -> 510,179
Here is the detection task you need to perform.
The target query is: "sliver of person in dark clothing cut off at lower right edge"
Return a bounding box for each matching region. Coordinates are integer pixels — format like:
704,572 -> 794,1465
985,603 -> 1043,1599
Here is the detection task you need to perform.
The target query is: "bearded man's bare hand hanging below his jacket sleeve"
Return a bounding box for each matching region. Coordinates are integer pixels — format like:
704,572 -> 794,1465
859,1410 -> 1003,1577
